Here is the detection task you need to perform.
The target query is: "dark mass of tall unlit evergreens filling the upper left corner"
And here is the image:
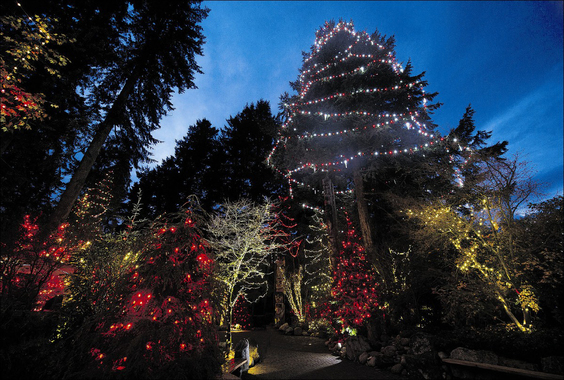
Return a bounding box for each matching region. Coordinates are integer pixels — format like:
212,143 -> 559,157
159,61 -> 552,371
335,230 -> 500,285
1,0 -> 209,240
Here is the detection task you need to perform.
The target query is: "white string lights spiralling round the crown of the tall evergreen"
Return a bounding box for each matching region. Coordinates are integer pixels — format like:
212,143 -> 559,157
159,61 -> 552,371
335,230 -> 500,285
267,18 -> 443,202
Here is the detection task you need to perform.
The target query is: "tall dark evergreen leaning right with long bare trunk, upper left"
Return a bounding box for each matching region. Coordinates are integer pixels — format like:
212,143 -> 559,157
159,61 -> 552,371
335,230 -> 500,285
43,1 -> 209,235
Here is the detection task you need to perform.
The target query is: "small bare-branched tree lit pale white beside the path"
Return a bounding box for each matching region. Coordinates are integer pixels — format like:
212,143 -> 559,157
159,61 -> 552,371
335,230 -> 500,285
206,199 -> 286,332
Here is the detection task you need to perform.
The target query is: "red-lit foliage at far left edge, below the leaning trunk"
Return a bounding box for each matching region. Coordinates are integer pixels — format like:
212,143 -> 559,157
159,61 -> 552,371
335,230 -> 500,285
0,173 -> 112,310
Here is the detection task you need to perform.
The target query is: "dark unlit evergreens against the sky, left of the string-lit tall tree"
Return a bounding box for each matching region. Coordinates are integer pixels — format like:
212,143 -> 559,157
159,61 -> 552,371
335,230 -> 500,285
128,100 -> 283,218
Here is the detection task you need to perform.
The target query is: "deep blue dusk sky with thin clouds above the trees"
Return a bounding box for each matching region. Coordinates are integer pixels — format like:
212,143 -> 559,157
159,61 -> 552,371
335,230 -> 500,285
148,1 -> 564,197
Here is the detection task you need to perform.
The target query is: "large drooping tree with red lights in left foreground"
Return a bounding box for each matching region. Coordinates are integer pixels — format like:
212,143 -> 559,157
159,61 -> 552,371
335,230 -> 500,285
56,202 -> 219,379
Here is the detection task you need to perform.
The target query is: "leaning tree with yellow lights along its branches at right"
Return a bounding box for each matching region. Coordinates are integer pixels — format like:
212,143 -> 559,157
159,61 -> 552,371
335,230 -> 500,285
408,154 -> 539,331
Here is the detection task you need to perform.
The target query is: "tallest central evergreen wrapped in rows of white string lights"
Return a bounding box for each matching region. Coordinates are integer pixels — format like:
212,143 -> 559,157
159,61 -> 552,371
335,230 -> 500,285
268,21 -> 440,272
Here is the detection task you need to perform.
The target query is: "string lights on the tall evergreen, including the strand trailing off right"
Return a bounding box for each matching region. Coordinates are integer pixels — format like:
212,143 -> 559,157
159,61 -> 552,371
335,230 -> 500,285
267,22 -> 480,217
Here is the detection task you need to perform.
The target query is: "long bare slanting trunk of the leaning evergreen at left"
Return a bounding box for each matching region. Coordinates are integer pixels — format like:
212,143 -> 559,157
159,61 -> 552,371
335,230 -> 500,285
45,66 -> 142,234
